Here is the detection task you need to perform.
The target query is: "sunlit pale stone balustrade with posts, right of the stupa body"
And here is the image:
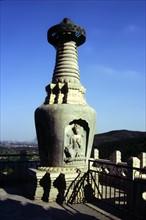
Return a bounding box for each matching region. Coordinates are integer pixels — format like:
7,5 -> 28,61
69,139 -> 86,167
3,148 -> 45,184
90,149 -> 146,180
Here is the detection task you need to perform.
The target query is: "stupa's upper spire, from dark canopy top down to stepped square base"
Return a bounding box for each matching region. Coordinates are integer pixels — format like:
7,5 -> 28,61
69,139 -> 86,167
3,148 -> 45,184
46,18 -> 86,104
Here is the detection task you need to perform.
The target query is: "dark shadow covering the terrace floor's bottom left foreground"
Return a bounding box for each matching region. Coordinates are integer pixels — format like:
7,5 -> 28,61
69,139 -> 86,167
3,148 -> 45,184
0,199 -> 98,220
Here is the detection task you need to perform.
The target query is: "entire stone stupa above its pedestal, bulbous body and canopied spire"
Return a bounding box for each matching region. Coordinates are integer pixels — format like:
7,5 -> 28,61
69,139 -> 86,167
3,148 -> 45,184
35,18 -> 96,167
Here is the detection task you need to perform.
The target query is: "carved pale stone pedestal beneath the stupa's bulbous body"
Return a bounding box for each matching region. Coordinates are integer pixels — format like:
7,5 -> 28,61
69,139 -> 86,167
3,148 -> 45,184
27,167 -> 87,202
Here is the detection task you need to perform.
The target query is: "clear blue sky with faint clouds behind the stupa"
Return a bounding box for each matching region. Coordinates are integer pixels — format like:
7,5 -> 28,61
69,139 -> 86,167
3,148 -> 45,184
0,0 -> 146,140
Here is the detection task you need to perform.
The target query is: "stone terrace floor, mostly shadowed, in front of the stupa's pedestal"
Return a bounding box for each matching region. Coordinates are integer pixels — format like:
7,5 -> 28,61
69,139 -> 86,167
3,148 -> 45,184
0,187 -> 131,220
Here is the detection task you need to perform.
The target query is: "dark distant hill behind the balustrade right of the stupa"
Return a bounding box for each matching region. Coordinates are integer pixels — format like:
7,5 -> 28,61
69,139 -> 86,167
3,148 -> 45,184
92,130 -> 146,161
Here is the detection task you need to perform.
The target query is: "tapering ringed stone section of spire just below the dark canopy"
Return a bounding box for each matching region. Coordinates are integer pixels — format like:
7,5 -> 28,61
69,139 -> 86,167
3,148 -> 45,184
52,41 -> 80,83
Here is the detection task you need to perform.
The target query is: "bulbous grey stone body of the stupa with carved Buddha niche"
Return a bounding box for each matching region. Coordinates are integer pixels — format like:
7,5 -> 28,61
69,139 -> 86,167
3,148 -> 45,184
36,105 -> 96,166
